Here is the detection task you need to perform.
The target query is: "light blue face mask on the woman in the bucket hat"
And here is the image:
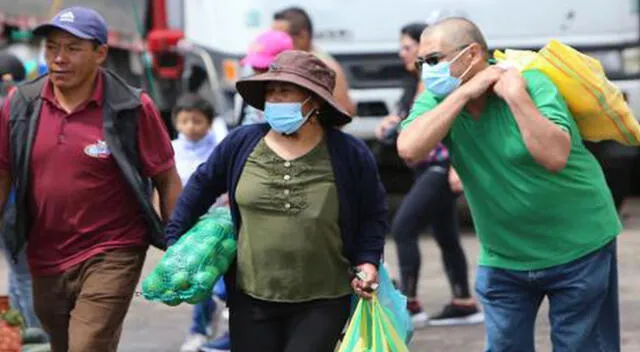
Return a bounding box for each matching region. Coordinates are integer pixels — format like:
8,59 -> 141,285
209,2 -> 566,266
264,98 -> 314,135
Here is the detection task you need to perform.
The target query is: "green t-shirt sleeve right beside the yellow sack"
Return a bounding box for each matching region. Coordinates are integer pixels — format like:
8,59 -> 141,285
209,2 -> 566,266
523,70 -> 577,132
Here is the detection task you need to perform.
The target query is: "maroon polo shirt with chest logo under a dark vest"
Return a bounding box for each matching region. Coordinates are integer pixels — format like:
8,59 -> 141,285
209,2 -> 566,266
0,72 -> 174,276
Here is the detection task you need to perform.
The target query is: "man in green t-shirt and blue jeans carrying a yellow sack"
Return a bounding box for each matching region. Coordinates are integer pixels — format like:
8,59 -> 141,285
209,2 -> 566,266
398,18 -> 622,352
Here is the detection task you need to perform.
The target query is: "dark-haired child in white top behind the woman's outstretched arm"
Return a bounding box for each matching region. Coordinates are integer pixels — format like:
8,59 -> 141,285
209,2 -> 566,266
172,94 -> 230,352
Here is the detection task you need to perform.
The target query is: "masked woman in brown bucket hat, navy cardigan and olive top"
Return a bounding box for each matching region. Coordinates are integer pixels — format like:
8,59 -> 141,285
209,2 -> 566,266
167,51 -> 388,352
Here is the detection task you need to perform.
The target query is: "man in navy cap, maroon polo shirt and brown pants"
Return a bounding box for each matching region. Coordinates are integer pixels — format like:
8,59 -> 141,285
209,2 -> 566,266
0,7 -> 181,352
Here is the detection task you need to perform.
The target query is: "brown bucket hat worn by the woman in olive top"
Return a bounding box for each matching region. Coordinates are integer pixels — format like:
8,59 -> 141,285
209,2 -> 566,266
236,50 -> 351,126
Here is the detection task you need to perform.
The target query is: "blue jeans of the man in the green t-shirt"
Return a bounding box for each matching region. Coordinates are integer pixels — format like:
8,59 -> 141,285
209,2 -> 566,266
476,240 -> 620,352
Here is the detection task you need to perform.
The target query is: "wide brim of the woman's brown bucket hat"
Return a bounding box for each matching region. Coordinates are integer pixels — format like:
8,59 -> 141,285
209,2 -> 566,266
236,71 -> 351,126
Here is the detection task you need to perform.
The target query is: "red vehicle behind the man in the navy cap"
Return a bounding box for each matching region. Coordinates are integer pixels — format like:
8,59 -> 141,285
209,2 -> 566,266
0,0 -> 185,136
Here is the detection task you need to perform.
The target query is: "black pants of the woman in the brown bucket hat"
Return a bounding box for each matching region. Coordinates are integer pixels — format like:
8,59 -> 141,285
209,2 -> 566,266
229,292 -> 351,352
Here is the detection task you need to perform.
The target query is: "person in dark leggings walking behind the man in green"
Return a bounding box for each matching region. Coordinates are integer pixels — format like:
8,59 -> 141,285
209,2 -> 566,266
376,23 -> 483,328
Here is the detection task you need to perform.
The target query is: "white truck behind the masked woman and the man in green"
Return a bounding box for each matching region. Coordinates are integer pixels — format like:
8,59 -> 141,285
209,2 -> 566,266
176,0 -> 640,202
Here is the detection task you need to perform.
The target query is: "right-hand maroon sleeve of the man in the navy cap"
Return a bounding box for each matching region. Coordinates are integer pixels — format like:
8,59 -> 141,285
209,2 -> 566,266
138,94 -> 175,177
